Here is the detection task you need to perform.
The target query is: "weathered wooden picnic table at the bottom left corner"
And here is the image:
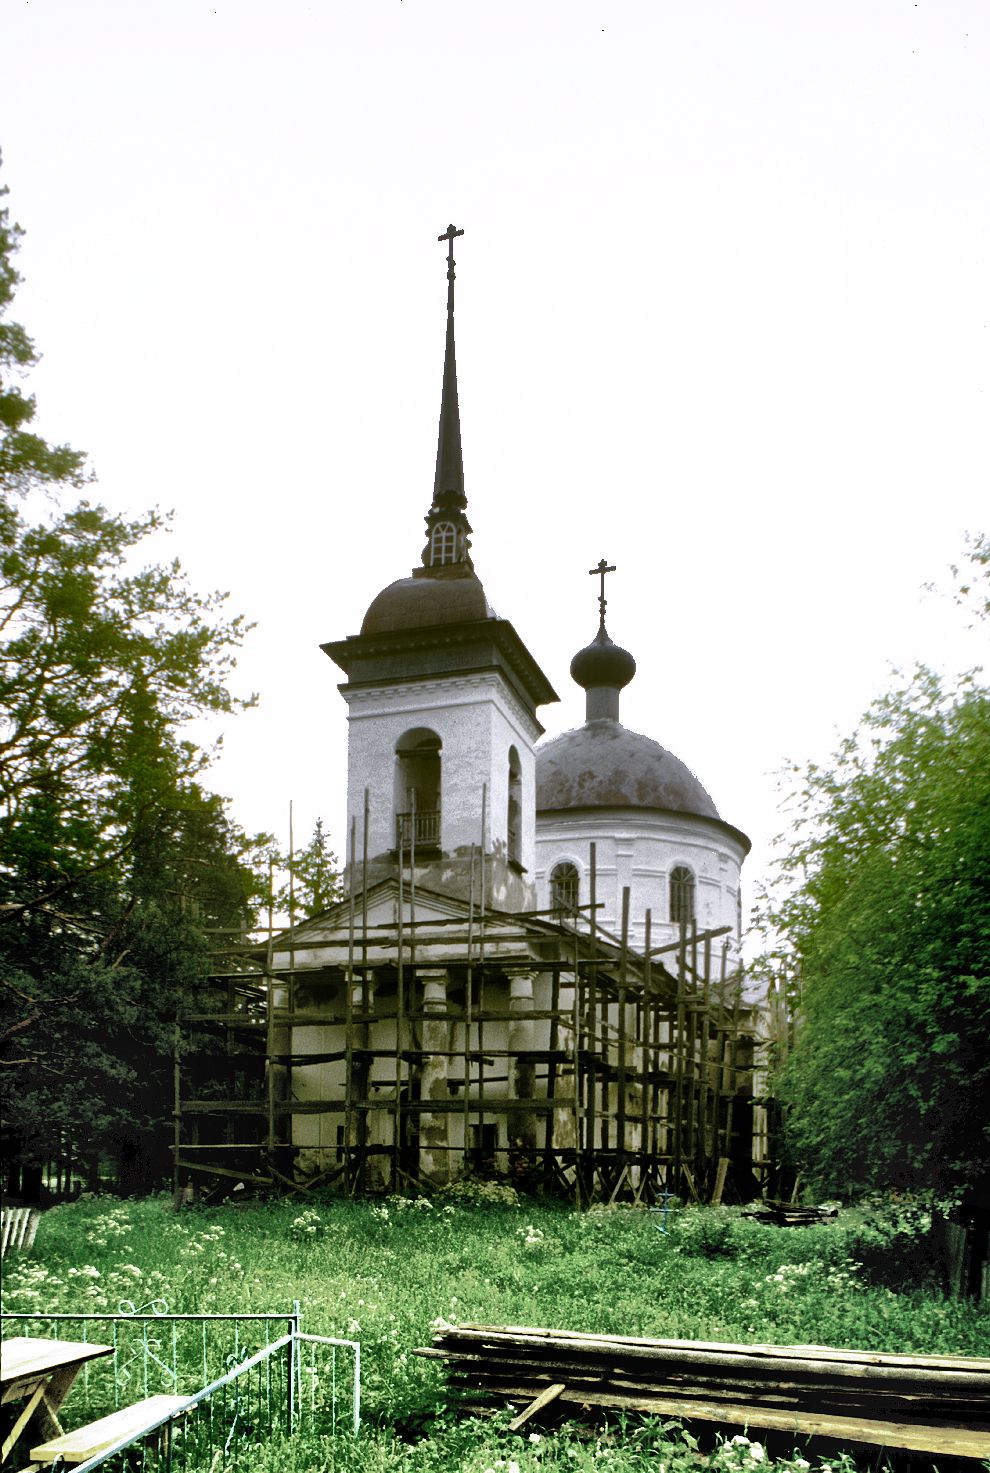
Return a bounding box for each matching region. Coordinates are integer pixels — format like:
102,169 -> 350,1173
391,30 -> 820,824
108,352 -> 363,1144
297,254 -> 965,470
0,1336 -> 113,1463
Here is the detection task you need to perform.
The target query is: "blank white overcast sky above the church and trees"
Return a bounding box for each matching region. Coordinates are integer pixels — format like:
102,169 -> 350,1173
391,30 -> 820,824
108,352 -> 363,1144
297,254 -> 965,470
0,0 -> 990,925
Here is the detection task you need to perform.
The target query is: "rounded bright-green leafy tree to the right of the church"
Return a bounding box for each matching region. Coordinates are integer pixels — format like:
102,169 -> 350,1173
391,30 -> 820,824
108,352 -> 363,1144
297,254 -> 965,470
751,539 -> 990,1196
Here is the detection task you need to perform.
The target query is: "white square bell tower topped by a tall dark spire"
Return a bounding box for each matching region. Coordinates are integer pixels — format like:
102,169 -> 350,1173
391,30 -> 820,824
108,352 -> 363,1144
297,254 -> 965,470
321,225 -> 557,910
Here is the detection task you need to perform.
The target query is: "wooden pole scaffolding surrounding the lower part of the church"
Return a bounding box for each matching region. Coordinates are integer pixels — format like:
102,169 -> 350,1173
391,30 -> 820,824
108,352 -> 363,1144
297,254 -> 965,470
174,846 -> 762,1205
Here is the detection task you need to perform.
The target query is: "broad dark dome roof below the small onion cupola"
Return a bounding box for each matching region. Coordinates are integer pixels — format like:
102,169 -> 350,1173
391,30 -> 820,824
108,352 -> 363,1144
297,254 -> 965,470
536,720 -> 720,822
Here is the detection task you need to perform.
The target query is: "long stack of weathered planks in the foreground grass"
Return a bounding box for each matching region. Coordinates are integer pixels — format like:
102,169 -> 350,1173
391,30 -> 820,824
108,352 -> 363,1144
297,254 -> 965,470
415,1324 -> 990,1457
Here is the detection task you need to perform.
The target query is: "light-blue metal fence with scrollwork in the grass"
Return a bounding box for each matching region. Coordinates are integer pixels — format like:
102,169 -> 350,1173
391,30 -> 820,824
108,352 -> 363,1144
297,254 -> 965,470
0,1305 -> 361,1473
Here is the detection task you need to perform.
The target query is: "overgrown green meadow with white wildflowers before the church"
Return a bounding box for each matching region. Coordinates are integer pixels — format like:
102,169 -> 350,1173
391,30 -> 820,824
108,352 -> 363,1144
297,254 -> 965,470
4,1186 -> 990,1473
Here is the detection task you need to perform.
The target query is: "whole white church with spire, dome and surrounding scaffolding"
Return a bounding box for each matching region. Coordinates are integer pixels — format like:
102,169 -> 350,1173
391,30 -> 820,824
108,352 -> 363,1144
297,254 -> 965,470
175,225 -> 762,1202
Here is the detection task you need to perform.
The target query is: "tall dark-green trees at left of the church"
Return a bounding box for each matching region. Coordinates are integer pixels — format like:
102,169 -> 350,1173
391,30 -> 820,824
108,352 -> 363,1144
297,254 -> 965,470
0,164 -> 265,1190
